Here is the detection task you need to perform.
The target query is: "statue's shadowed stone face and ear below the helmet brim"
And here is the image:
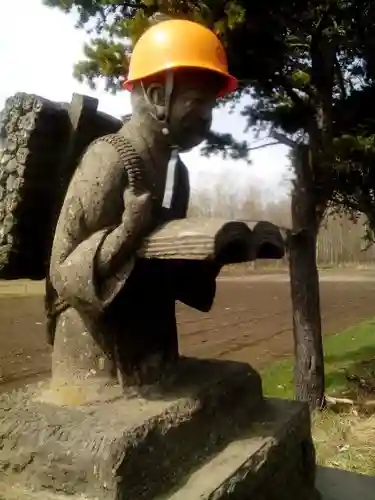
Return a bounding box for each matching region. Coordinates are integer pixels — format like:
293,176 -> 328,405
140,70 -> 223,151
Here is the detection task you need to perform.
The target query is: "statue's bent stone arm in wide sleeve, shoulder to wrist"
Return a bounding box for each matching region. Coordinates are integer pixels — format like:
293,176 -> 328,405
50,143 -> 150,311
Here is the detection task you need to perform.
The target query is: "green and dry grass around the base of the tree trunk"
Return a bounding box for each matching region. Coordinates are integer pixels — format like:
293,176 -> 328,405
262,319 -> 375,476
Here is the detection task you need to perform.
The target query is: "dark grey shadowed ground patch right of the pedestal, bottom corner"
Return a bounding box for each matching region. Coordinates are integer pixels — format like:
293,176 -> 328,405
317,467 -> 375,500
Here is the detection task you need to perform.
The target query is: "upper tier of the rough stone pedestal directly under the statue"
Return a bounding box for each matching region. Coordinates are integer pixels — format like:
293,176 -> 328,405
0,359 -> 263,500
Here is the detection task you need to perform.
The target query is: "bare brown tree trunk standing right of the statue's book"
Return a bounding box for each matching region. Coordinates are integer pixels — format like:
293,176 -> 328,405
289,147 -> 325,410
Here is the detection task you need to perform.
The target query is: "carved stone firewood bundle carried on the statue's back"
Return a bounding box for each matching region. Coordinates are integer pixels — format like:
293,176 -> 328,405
0,93 -> 70,280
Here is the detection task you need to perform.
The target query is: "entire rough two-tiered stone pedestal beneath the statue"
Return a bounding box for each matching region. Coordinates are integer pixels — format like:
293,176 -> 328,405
0,359 -> 317,500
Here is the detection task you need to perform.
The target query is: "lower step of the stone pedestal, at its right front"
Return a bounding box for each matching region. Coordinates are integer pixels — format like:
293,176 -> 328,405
157,399 -> 319,500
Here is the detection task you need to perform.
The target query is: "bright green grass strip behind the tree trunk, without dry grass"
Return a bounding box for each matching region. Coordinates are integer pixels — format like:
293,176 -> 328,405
262,319 -> 375,398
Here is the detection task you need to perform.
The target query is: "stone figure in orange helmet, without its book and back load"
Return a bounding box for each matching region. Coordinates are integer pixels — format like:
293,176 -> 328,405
50,21 -> 236,398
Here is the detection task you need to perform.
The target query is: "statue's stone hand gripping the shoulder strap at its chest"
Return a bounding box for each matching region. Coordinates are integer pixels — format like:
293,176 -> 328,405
124,189 -> 154,235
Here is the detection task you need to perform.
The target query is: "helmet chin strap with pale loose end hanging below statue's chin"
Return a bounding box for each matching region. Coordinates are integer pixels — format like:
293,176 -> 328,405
141,71 -> 178,209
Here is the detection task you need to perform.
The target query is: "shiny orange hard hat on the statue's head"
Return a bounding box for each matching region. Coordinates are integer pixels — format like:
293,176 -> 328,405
124,19 -> 238,97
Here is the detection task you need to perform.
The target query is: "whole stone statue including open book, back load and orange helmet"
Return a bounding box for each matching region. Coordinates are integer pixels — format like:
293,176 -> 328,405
0,17 -> 284,401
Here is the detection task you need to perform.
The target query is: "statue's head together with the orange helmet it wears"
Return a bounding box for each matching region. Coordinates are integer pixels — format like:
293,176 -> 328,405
124,20 -> 237,151
